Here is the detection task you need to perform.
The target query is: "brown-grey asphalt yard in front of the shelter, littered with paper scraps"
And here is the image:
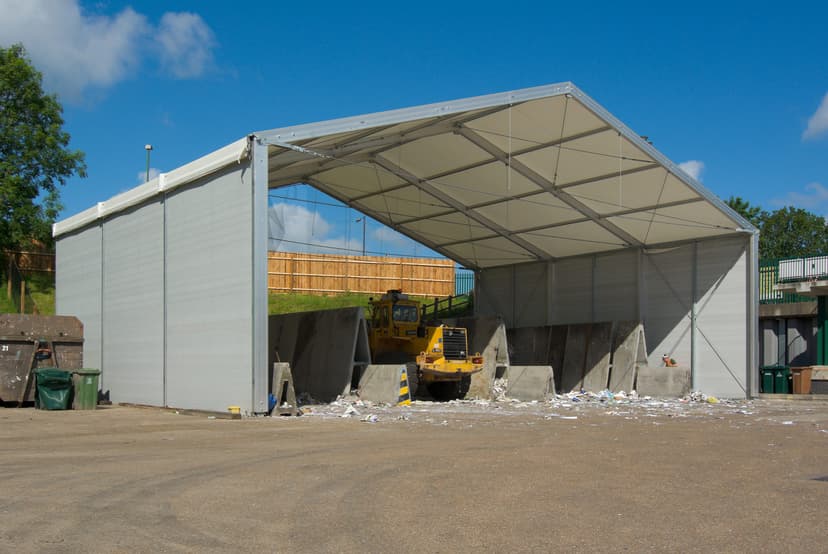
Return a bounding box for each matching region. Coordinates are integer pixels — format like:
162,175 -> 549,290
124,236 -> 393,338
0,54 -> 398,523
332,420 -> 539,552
0,394 -> 828,552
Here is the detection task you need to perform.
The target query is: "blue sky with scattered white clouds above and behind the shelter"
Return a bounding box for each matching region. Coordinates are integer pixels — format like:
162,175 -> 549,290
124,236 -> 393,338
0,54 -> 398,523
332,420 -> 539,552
0,0 -> 828,254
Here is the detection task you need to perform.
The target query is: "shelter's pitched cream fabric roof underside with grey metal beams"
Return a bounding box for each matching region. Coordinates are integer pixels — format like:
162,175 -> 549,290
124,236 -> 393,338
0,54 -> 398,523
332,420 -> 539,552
256,83 -> 753,268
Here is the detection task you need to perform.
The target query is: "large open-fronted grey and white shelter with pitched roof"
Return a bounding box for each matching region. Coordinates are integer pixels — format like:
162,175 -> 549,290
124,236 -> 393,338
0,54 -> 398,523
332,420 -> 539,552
54,83 -> 757,412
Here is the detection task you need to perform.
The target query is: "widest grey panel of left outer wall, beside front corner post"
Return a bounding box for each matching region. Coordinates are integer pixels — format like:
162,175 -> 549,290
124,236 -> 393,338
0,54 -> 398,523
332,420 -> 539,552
166,167 -> 253,411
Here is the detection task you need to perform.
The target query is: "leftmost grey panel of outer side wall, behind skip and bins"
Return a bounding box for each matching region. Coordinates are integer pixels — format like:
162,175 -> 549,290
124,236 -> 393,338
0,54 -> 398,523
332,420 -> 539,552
55,225 -> 102,382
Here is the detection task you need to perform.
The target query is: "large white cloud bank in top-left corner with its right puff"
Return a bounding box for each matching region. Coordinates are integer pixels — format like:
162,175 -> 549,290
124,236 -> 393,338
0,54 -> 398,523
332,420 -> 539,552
0,0 -> 215,102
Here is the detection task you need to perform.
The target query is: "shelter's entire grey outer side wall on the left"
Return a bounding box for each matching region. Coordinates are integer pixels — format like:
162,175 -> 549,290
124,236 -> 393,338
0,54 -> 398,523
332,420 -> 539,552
56,164 -> 258,412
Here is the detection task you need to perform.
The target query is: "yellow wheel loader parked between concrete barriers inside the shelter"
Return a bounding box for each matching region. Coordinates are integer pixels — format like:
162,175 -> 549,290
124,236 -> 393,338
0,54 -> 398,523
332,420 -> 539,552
368,290 -> 483,400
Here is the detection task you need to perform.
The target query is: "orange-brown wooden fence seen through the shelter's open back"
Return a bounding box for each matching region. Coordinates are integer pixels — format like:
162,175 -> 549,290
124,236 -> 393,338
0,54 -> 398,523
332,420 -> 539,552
267,252 -> 454,297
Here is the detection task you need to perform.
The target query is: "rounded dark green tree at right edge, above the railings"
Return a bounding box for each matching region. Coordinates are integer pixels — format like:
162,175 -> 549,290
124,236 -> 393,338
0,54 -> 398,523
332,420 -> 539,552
759,207 -> 828,259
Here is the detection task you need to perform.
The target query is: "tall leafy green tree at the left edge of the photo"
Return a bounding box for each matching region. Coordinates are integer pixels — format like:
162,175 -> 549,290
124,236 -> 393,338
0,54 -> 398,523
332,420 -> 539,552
0,44 -> 86,250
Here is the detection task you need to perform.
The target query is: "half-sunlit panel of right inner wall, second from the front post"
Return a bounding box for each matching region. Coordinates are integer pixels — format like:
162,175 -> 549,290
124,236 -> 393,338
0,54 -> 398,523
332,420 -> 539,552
643,245 -> 692,367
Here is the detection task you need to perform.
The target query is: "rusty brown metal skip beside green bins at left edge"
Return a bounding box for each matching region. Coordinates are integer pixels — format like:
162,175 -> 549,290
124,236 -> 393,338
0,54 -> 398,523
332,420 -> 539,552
0,314 -> 83,405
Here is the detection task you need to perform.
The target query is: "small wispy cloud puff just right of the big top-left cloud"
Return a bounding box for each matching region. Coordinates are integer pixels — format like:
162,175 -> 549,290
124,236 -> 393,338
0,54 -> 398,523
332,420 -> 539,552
155,12 -> 216,79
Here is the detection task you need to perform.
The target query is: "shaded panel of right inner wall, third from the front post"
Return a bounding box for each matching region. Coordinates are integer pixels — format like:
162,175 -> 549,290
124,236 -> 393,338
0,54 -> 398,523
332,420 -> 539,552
594,252 -> 638,321
